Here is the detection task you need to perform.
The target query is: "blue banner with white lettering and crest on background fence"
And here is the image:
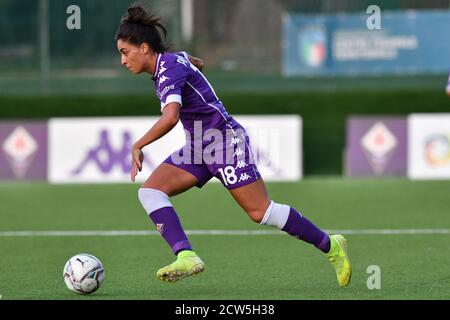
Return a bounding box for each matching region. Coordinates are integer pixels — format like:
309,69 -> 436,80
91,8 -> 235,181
283,10 -> 450,76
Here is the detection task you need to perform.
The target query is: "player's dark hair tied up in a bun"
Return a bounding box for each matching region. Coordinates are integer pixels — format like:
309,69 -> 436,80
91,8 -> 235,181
115,4 -> 169,53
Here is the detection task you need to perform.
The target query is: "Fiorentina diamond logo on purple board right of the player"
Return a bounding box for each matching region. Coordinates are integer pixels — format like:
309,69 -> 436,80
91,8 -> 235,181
361,122 -> 398,175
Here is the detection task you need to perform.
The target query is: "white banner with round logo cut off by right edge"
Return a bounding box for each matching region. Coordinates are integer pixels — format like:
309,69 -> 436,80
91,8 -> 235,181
408,114 -> 450,179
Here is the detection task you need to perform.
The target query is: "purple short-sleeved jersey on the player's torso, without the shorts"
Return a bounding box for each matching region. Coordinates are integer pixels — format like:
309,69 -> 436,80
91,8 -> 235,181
153,52 -> 234,133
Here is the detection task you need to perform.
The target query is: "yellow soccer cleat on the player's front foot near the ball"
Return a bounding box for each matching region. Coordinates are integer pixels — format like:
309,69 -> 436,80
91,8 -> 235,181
156,250 -> 205,282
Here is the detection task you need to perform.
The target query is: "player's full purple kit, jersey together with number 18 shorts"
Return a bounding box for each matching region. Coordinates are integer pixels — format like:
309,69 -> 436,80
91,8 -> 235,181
153,52 -> 261,189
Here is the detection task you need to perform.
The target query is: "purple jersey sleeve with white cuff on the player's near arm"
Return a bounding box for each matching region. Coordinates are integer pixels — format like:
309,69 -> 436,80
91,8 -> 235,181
157,56 -> 188,111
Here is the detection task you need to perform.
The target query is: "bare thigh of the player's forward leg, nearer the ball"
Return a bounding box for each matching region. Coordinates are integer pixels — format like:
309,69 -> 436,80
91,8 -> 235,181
142,163 -> 198,197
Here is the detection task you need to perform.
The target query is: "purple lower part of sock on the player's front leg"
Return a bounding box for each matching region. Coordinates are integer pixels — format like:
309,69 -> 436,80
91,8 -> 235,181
149,207 -> 192,254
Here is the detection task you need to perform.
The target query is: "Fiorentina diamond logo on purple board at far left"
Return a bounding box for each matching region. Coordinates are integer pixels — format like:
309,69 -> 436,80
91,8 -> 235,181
2,126 -> 39,178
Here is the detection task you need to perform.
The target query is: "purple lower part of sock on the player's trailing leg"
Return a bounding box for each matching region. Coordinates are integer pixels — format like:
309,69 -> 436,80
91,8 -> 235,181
282,207 -> 330,253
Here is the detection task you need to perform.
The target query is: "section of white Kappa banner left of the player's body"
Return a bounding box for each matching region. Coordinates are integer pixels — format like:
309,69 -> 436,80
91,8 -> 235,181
48,117 -> 184,183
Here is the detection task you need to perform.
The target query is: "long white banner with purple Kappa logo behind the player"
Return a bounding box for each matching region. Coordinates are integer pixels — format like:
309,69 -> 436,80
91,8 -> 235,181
48,116 -> 302,183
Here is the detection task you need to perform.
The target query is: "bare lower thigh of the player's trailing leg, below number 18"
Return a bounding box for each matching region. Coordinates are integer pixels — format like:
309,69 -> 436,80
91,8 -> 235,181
229,178 -> 270,223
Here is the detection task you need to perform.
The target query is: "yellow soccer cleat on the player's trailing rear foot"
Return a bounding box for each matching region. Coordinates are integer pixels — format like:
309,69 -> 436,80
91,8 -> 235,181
327,234 -> 352,287
